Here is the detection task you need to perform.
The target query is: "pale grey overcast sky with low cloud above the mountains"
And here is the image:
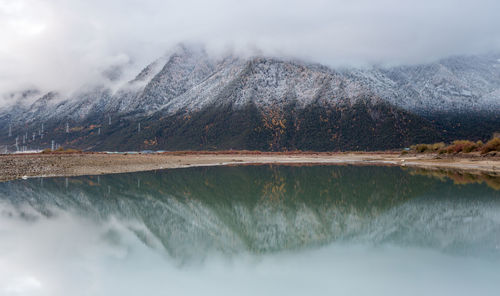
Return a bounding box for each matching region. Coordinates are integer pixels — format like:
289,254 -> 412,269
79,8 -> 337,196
0,0 -> 500,100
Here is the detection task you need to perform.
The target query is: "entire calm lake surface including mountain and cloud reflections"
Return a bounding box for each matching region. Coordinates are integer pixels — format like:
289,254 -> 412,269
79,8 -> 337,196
0,166 -> 500,295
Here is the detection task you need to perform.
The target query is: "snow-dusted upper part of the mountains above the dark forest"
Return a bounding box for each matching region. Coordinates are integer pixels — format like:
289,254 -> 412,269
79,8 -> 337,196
0,45 -> 500,149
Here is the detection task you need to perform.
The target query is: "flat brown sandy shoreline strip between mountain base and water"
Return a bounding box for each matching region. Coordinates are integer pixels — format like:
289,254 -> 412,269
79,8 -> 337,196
0,152 -> 500,181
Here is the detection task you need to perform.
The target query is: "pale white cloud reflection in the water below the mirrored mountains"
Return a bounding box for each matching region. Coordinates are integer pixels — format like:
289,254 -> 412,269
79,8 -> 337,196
0,206 -> 500,296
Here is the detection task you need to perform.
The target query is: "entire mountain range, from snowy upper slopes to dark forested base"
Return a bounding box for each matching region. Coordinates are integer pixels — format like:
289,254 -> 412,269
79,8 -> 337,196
0,46 -> 500,151
